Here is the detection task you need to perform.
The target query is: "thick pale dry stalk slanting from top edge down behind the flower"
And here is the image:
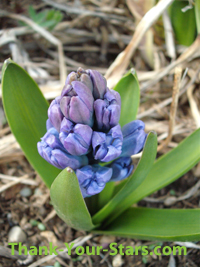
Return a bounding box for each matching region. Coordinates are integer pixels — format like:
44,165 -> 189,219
105,0 -> 174,88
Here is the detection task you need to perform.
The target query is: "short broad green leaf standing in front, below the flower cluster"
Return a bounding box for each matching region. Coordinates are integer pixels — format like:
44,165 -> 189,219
50,167 -> 94,231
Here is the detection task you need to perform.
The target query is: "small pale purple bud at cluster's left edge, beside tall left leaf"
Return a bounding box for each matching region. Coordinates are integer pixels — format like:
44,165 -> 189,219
48,96 -> 64,132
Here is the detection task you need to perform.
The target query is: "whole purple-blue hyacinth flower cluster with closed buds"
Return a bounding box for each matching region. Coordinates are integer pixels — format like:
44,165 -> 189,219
38,68 -> 147,198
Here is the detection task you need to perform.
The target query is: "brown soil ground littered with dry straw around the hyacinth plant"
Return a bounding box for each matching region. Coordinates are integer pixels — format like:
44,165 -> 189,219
0,0 -> 200,267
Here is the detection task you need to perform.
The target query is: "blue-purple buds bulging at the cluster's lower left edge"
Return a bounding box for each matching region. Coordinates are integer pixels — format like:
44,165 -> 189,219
37,128 -> 88,170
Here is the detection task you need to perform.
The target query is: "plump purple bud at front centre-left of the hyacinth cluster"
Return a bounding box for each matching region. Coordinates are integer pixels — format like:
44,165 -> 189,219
59,118 -> 93,156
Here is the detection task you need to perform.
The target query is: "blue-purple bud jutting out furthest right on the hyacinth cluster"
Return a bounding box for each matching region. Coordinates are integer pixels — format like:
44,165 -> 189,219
121,120 -> 147,157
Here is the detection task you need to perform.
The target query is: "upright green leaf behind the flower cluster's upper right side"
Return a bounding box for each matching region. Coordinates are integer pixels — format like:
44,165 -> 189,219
114,69 -> 140,127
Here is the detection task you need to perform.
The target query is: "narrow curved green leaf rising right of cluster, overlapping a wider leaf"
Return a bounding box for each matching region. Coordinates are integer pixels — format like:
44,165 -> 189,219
92,132 -> 157,225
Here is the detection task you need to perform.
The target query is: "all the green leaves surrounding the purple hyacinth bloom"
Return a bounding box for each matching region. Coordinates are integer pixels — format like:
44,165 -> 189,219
2,60 -> 200,241
